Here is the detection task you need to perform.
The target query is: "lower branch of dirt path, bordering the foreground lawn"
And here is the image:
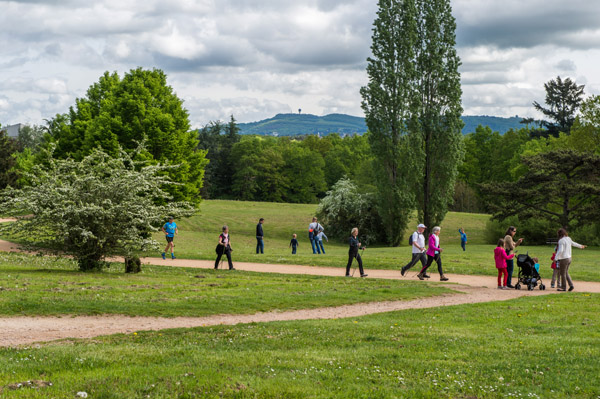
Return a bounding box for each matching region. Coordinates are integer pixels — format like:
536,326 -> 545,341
0,286 -> 548,346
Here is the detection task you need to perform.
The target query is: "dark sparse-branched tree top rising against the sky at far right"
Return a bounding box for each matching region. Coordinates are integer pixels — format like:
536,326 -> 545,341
533,76 -> 584,136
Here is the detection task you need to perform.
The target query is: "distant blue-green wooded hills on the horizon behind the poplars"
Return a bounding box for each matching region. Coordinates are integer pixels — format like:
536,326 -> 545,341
239,114 -> 523,136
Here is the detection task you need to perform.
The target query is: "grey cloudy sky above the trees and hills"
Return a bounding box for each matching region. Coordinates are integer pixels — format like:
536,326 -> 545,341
0,0 -> 600,127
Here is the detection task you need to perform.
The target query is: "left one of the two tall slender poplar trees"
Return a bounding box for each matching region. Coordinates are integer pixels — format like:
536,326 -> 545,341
361,0 -> 418,246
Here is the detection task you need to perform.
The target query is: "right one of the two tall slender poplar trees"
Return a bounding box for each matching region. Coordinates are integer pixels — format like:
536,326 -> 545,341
409,0 -> 463,228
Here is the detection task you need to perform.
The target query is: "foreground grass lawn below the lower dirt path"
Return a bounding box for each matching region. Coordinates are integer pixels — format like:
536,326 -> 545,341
0,294 -> 600,399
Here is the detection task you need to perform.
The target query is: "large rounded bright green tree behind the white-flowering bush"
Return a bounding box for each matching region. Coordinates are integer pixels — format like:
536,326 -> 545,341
48,68 -> 207,201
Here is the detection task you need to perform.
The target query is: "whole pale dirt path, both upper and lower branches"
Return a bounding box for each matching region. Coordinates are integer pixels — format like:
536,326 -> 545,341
0,239 -> 600,347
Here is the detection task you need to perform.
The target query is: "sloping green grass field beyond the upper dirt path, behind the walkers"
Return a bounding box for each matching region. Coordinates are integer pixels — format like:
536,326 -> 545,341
155,201 -> 600,281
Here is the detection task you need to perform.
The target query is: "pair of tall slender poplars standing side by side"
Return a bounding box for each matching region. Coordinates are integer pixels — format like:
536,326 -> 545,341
361,0 -> 463,245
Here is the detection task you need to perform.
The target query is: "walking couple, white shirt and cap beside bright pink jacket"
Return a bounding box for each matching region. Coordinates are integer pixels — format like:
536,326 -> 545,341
401,224 -> 448,281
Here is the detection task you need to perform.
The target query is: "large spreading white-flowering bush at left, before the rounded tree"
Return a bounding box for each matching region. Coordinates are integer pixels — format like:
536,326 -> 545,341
0,148 -> 194,270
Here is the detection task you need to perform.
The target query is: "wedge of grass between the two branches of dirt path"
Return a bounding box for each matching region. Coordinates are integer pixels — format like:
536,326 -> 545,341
0,253 -> 449,317
